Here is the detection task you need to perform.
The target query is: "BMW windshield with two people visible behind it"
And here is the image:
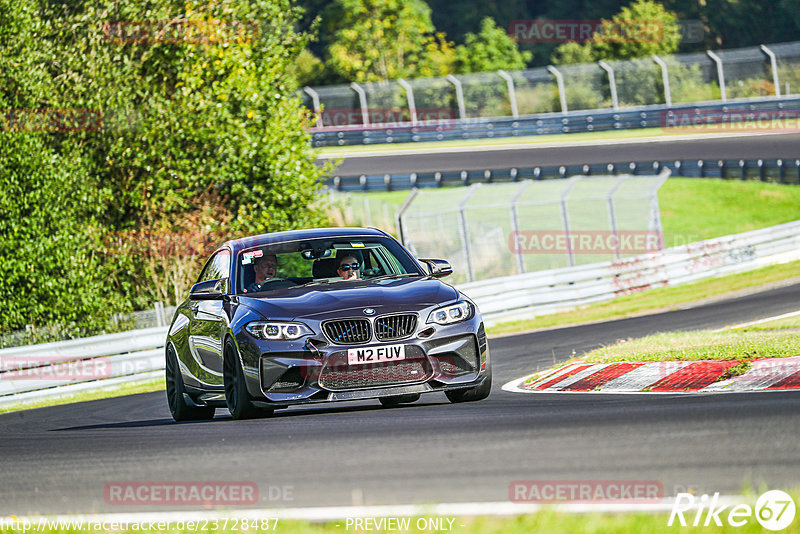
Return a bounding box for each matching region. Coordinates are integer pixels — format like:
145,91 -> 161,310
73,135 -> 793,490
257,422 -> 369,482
236,236 -> 425,294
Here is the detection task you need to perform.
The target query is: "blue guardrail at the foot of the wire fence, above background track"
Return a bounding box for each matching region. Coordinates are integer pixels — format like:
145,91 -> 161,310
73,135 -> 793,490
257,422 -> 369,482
312,96 -> 800,147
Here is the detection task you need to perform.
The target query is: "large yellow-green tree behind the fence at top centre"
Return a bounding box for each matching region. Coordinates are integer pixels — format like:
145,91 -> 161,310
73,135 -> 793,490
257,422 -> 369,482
324,0 -> 455,82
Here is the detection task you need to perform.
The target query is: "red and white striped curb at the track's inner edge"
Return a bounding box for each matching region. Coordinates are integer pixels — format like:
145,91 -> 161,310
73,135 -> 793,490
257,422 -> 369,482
503,356 -> 800,393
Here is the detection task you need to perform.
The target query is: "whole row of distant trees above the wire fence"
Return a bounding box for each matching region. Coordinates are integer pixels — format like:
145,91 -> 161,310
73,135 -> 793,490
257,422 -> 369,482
294,0 -> 800,85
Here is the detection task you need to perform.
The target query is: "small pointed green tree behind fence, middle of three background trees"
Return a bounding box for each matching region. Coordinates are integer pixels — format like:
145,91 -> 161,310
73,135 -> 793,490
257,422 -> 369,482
456,17 -> 532,74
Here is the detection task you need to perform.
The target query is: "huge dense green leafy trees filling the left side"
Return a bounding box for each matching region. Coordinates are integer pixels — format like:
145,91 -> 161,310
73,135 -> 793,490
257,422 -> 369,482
0,0 -> 326,336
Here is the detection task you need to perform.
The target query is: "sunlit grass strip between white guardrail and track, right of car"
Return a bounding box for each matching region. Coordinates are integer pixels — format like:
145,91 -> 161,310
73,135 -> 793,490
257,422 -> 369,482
486,261 -> 800,338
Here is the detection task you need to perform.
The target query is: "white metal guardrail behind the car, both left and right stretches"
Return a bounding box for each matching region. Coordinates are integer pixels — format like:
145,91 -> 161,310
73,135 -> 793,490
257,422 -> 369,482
0,221 -> 800,405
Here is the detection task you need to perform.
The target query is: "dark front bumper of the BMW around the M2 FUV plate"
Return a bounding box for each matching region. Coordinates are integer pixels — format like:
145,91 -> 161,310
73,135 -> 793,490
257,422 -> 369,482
238,316 -> 490,406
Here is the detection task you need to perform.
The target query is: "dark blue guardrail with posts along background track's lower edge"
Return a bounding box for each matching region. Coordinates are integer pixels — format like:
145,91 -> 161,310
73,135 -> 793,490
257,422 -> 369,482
325,158 -> 800,193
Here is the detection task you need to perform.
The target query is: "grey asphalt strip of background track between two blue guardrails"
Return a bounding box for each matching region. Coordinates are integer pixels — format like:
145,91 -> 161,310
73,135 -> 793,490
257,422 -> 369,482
322,134 -> 800,176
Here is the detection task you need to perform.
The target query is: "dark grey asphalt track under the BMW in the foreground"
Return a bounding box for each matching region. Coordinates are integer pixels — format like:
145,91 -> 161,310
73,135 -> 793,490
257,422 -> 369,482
0,284 -> 800,516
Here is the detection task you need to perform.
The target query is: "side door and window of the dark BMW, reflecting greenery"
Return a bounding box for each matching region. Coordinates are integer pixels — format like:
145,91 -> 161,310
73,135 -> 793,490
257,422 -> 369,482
189,249 -> 231,386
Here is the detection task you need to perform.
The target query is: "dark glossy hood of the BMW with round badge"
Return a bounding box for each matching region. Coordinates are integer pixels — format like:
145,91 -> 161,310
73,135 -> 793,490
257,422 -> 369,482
239,278 -> 458,321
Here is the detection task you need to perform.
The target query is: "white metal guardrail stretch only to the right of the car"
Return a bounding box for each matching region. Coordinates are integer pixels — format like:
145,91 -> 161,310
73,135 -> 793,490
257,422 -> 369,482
458,221 -> 800,325
